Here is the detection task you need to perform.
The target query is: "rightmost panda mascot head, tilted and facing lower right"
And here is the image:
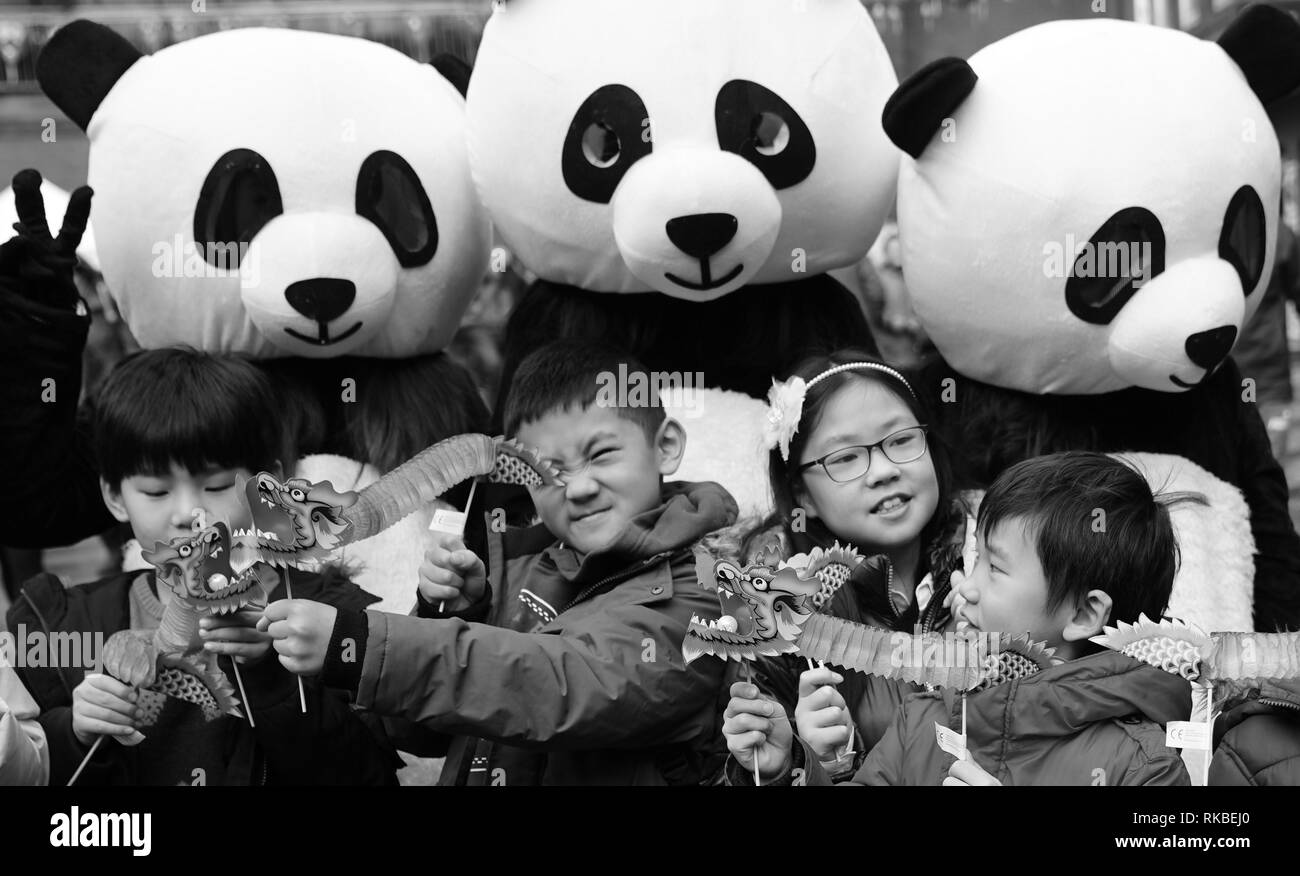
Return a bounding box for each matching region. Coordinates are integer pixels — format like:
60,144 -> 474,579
884,6 -> 1300,394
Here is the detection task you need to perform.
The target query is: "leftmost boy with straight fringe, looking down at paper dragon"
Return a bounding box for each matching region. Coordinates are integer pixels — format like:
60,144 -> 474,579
7,350 -> 400,785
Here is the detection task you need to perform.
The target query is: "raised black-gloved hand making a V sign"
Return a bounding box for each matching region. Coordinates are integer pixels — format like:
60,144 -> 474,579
0,168 -> 92,311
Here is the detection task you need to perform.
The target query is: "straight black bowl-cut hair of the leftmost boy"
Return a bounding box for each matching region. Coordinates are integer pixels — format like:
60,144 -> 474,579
92,347 -> 286,489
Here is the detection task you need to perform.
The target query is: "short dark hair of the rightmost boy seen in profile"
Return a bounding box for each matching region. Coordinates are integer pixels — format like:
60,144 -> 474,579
978,451 -> 1179,625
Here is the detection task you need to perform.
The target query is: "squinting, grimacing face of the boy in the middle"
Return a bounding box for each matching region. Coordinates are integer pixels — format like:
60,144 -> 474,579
515,404 -> 685,555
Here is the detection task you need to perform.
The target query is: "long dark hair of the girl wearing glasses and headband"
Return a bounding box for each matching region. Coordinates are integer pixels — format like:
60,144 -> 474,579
742,348 -> 954,558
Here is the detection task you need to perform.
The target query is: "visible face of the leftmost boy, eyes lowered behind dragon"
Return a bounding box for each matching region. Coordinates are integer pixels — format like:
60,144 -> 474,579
100,463 -> 252,550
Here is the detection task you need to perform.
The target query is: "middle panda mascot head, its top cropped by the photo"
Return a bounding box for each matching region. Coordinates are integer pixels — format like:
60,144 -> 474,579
468,0 -> 897,300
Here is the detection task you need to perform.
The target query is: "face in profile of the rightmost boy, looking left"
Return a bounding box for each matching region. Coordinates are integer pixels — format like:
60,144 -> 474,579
957,517 -> 1075,649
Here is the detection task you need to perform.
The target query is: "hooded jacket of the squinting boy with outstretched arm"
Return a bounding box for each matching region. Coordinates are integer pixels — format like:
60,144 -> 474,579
325,483 -> 736,785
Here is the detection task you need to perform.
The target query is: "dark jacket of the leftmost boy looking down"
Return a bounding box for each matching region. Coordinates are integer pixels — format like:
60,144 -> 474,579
7,572 -> 402,785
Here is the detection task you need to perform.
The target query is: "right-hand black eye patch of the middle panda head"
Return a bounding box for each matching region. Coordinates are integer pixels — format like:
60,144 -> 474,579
714,79 -> 816,190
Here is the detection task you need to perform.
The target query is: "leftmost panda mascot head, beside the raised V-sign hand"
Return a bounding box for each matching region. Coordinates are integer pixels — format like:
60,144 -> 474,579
38,21 -> 490,357
